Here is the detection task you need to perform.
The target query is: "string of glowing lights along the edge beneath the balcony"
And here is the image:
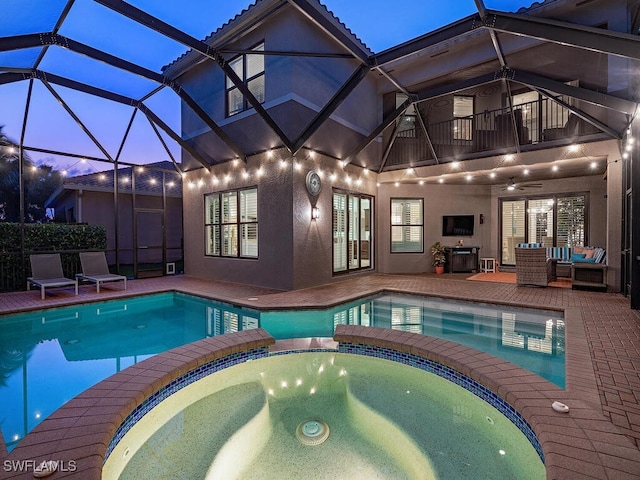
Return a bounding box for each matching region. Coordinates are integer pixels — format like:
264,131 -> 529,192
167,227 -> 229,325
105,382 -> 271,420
378,144 -> 600,186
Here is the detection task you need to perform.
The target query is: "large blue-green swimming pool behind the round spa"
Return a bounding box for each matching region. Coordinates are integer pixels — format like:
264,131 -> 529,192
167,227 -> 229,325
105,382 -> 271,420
0,293 -> 565,450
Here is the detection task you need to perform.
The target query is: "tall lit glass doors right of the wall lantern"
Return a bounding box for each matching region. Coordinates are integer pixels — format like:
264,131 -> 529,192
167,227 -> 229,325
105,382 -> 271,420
333,192 -> 373,273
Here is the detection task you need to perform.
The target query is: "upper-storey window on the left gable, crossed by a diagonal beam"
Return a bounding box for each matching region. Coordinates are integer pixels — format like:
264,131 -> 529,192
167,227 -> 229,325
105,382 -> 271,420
225,43 -> 264,117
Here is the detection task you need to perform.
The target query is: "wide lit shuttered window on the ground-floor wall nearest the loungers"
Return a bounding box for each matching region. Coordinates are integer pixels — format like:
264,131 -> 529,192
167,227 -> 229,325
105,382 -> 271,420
205,188 -> 258,258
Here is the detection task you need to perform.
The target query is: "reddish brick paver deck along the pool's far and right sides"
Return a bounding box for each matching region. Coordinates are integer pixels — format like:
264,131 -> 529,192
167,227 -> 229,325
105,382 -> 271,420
0,274 -> 640,478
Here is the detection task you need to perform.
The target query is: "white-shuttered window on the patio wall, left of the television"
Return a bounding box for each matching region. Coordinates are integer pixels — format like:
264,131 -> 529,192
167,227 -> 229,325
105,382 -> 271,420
391,198 -> 424,253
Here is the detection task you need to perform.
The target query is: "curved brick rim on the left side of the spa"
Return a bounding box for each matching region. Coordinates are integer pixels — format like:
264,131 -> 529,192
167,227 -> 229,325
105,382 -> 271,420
0,328 -> 275,480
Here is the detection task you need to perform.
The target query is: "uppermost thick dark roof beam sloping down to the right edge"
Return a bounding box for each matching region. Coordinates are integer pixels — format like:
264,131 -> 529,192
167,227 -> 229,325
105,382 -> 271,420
474,10 -> 640,60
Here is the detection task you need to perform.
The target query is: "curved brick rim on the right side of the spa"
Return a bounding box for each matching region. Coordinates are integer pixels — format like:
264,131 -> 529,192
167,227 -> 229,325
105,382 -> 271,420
334,325 -> 640,480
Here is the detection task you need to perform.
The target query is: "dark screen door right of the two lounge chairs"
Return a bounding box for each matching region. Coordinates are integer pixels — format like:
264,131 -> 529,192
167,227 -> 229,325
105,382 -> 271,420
133,209 -> 166,278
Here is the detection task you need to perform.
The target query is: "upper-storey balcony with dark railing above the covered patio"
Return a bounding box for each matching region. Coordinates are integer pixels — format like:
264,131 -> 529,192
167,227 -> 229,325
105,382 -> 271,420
385,99 -> 606,167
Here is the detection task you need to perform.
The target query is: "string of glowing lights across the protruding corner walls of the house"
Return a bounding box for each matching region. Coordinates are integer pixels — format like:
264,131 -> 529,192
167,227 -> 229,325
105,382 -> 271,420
182,148 -> 370,189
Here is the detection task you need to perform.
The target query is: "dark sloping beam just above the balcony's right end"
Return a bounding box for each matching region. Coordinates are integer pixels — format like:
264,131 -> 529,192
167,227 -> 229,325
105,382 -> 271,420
511,70 -> 638,115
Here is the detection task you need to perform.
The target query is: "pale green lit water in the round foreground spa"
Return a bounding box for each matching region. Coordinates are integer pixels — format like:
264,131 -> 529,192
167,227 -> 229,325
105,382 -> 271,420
103,352 -> 545,480
